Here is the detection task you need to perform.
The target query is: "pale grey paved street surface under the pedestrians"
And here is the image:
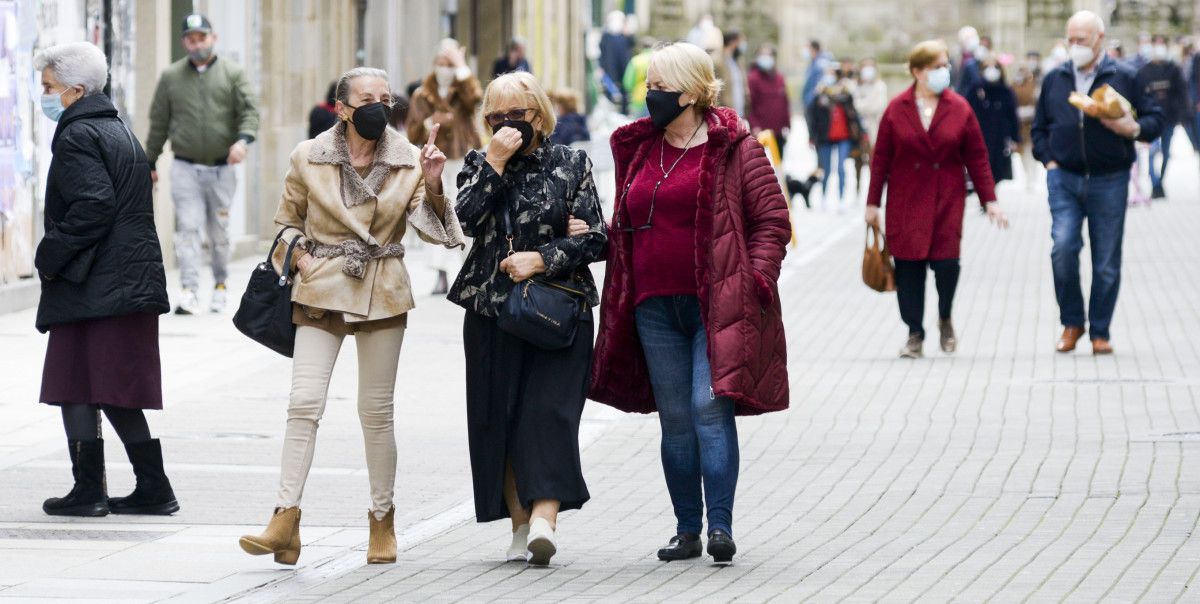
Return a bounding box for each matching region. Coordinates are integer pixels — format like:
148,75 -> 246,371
0,131 -> 1200,602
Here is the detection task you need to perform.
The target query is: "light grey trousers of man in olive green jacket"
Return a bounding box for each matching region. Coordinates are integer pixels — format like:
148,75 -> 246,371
170,160 -> 238,291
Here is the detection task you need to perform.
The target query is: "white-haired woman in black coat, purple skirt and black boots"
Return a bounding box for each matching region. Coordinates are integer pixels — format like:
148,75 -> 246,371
34,42 -> 179,516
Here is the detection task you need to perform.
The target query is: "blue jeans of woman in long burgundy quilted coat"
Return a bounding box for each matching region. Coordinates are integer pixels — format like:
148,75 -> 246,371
634,295 -> 739,536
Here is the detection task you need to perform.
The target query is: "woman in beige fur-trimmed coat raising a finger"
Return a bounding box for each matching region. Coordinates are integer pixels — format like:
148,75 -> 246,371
240,67 -> 463,564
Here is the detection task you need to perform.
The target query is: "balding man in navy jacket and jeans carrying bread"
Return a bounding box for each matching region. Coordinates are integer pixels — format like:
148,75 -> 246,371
1033,11 -> 1163,354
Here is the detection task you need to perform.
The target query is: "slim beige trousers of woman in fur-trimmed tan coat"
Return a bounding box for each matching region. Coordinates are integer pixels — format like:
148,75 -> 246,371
278,325 -> 404,518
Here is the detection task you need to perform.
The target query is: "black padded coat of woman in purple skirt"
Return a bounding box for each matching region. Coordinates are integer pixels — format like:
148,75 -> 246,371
34,95 -> 170,333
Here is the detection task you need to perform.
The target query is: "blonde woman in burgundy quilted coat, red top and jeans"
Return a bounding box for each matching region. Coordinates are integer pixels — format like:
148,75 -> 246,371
589,42 -> 791,562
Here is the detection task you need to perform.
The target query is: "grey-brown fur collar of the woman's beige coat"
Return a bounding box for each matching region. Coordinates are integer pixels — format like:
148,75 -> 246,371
308,121 -> 416,208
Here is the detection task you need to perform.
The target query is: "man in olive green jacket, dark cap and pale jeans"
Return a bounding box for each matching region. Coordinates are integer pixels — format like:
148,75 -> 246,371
146,14 -> 258,315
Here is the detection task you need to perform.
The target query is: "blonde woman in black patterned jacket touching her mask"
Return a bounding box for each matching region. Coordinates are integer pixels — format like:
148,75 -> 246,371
450,72 -> 607,566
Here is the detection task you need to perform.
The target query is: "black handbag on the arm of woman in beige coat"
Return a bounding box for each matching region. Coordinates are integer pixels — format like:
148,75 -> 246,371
233,231 -> 300,358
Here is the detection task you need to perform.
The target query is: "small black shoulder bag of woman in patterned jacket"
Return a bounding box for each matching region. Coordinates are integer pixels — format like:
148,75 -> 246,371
496,193 -> 588,351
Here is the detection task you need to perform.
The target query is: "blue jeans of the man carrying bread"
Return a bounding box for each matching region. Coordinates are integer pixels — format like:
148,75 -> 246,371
1046,168 -> 1129,340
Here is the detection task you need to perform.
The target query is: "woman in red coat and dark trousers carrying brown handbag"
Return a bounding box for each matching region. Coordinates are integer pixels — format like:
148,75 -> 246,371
866,41 -> 1008,359
